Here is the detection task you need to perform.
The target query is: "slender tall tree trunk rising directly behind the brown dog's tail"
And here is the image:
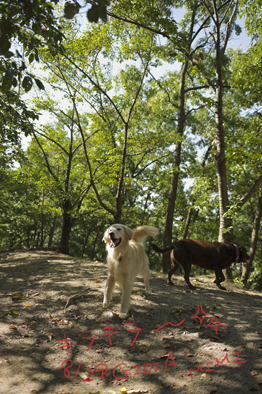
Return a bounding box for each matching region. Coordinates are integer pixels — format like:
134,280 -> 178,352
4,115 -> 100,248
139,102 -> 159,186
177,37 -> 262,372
163,61 -> 188,272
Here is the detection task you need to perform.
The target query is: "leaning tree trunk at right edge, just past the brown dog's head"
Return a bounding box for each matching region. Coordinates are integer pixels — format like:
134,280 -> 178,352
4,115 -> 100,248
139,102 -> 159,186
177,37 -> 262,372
242,196 -> 262,286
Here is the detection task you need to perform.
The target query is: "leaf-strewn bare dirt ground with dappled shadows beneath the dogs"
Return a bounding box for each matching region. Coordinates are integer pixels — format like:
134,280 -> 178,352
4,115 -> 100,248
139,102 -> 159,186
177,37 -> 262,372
0,251 -> 262,394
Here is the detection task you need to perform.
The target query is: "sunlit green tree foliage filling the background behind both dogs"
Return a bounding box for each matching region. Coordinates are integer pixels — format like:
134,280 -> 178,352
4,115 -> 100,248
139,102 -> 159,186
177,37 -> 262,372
0,1 -> 262,287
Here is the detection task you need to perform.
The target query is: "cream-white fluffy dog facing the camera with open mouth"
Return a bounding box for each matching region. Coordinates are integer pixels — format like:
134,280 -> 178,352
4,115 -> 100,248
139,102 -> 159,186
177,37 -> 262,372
103,224 -> 158,319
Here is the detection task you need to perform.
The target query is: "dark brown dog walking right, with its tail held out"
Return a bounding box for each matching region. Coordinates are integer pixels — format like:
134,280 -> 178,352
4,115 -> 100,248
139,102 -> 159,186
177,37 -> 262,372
151,239 -> 249,290
